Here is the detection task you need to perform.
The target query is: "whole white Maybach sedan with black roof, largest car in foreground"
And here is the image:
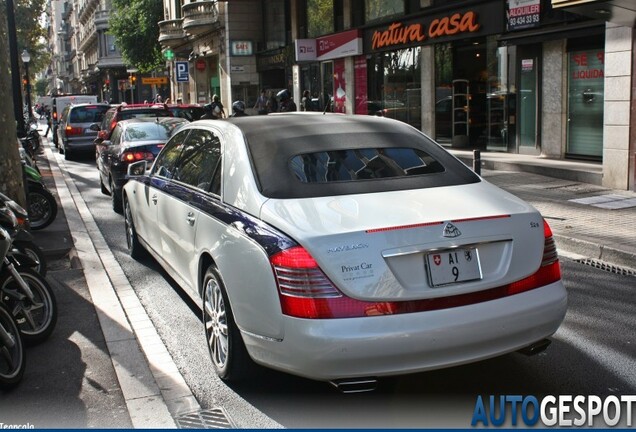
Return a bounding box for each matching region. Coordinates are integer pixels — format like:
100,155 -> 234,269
123,112 -> 567,391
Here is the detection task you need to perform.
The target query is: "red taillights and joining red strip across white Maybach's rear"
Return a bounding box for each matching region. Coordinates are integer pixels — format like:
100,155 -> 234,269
270,221 -> 561,319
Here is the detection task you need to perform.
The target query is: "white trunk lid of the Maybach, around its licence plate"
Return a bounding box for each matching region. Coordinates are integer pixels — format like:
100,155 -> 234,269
262,182 -> 544,301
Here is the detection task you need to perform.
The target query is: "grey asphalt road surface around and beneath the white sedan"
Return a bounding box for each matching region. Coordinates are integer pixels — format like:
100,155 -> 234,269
60,152 -> 636,428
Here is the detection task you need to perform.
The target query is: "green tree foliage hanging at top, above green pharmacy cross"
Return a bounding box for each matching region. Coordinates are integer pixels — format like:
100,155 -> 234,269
108,0 -> 164,73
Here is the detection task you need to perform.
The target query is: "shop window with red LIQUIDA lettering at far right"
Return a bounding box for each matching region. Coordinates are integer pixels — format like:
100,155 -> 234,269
567,49 -> 605,159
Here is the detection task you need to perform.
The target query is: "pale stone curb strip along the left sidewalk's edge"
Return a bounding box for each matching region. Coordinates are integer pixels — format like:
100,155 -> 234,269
45,144 -> 200,429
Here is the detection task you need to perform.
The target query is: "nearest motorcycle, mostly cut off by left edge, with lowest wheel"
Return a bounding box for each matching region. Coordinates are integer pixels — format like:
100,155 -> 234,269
0,228 -> 26,389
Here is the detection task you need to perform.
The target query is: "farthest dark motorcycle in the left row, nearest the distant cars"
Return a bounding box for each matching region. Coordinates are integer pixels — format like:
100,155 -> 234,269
22,163 -> 57,230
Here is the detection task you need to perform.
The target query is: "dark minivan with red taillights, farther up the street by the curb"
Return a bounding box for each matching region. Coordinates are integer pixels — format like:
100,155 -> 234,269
56,103 -> 110,160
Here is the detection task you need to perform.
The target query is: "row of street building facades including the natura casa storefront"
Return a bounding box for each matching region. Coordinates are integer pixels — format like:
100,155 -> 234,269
56,0 -> 636,190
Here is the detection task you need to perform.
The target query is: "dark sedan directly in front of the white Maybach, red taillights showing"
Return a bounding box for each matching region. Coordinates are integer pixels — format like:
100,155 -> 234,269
96,117 -> 188,212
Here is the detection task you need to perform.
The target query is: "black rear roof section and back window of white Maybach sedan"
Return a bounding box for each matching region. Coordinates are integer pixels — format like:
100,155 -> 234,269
234,115 -> 480,199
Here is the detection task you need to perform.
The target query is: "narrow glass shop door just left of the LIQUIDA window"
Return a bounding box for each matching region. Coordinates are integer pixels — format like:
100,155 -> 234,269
518,47 -> 541,154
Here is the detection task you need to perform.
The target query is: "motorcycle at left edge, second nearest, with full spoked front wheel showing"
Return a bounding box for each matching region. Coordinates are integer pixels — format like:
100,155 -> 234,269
0,203 -> 57,344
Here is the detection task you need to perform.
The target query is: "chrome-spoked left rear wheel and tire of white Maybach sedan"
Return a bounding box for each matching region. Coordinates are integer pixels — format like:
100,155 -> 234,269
202,265 -> 255,381
